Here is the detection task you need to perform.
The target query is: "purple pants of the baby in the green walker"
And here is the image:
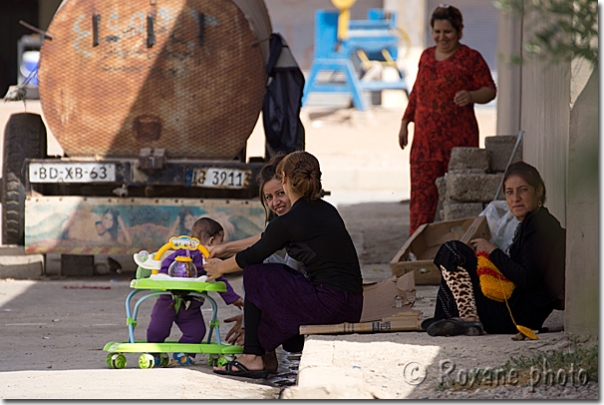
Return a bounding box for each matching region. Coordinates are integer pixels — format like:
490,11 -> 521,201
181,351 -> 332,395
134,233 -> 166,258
147,294 -> 206,343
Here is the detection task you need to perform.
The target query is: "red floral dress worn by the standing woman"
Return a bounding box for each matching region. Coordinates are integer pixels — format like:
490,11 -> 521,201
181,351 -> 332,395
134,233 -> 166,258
403,45 -> 497,235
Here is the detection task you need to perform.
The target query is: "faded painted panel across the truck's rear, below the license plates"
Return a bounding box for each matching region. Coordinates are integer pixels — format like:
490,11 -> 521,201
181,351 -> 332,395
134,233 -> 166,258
25,197 -> 265,255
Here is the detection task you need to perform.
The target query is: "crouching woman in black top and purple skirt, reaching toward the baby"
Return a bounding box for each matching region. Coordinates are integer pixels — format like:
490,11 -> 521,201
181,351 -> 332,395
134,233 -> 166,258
204,151 -> 363,378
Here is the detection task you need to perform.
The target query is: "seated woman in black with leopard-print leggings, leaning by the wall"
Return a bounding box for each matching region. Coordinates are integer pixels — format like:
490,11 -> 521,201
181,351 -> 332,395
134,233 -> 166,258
422,162 -> 566,336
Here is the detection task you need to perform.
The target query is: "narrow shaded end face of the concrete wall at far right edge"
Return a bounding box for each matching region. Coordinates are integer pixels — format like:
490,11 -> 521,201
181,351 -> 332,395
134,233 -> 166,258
564,70 -> 600,337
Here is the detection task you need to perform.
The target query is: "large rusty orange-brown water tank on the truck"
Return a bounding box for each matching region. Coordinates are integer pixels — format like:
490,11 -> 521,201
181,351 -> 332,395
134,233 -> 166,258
38,0 -> 272,159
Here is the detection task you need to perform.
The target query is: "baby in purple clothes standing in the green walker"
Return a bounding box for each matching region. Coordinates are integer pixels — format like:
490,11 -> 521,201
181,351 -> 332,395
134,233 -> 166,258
147,217 -> 243,365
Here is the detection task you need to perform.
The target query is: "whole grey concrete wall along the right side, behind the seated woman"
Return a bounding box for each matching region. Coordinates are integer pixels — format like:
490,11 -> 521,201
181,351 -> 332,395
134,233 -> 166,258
497,2 -> 599,336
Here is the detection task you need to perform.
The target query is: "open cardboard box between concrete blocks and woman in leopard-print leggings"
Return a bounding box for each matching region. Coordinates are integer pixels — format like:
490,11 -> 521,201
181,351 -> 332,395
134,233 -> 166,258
390,216 -> 491,285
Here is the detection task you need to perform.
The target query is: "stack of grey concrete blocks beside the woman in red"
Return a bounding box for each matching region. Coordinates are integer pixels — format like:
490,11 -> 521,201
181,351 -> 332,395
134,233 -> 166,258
436,135 -> 522,221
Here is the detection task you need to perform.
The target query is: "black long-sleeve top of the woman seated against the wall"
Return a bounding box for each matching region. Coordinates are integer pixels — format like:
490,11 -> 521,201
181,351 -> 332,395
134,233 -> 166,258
489,207 -> 566,309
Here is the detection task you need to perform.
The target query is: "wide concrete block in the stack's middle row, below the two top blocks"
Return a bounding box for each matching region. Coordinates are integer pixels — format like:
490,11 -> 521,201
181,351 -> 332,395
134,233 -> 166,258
447,172 -> 503,202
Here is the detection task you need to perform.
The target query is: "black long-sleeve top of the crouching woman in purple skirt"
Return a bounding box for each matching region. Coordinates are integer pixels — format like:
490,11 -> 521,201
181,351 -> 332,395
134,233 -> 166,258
235,198 -> 363,294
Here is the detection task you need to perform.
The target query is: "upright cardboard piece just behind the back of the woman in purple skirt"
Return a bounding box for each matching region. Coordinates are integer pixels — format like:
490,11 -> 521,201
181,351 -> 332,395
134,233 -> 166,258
360,272 -> 415,322
